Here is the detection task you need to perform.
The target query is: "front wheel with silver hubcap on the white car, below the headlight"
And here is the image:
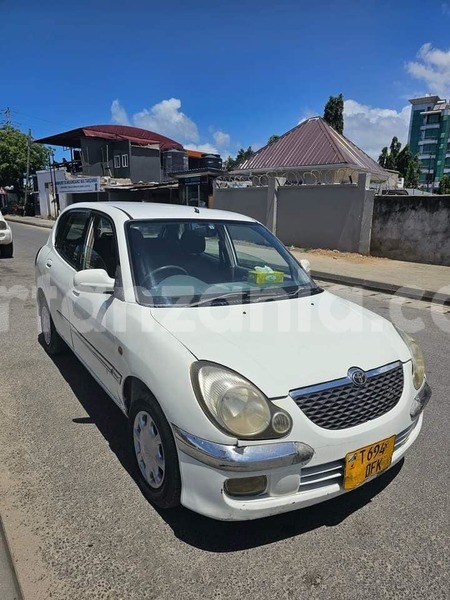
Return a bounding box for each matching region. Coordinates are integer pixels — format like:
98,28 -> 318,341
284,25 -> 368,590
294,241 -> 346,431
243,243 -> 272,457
129,391 -> 181,508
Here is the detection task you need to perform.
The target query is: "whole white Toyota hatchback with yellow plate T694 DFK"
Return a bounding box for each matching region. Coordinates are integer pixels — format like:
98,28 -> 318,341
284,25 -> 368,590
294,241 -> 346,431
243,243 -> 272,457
36,203 -> 431,520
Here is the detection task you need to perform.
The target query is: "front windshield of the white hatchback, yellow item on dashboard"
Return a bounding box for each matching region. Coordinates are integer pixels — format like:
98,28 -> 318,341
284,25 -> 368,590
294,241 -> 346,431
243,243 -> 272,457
127,220 -> 321,306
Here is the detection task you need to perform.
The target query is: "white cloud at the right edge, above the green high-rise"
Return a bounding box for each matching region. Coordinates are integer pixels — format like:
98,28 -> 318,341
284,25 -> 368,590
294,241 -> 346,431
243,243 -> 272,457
406,42 -> 450,97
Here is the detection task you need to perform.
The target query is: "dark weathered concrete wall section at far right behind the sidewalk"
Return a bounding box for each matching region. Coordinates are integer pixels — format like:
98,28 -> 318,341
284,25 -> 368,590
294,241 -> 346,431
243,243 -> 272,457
370,196 -> 450,266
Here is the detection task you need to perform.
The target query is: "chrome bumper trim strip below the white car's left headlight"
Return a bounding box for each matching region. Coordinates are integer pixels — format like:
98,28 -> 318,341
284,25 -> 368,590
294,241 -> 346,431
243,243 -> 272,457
172,425 -> 314,473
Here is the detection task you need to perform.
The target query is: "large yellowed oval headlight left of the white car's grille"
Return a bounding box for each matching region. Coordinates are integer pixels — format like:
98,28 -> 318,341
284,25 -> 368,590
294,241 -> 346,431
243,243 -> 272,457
191,361 -> 292,439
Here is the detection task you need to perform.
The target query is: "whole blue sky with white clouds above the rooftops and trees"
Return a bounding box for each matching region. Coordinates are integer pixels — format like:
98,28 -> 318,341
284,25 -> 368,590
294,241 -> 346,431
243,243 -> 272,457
0,0 -> 450,156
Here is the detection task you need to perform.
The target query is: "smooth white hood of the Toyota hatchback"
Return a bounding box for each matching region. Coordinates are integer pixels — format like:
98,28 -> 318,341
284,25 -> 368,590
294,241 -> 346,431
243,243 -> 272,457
151,292 -> 411,398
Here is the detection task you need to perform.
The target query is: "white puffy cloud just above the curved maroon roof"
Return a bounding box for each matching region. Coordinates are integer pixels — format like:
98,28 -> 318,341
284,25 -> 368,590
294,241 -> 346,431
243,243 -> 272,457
111,98 -> 199,142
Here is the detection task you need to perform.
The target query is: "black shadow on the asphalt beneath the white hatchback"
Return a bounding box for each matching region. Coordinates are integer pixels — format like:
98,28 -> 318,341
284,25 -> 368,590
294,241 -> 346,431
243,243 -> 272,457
44,340 -> 403,553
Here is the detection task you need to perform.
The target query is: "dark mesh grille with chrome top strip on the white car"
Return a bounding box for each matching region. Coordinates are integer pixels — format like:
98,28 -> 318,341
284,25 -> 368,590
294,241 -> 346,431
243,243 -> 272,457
290,362 -> 404,429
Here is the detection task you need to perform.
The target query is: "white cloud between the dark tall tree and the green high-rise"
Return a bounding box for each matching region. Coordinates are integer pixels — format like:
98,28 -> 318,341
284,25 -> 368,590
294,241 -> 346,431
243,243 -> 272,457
344,100 -> 411,160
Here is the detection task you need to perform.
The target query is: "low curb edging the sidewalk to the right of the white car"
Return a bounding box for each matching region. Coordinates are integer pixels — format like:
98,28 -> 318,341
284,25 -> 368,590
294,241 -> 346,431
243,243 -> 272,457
311,271 -> 450,306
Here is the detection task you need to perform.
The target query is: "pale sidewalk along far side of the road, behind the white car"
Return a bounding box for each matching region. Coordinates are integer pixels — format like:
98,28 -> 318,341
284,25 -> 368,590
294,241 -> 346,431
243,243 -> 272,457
6,215 -> 450,304
